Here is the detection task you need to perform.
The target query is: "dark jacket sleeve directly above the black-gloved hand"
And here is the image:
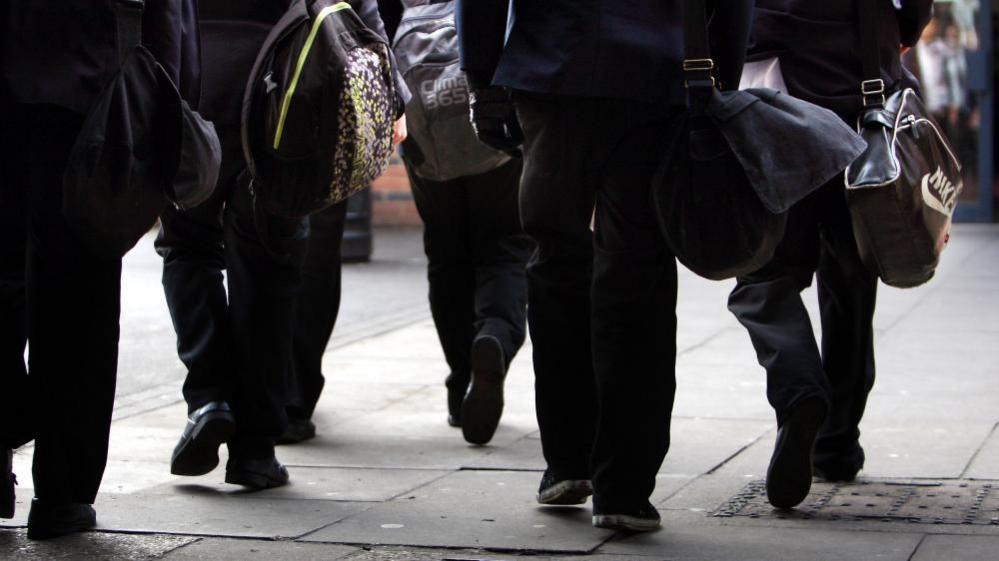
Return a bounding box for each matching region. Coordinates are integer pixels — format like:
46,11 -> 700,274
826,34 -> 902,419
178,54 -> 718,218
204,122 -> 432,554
455,0 -> 510,88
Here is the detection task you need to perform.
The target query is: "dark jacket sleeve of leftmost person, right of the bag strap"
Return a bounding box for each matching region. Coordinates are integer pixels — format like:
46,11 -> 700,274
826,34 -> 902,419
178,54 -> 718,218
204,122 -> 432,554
142,0 -> 201,104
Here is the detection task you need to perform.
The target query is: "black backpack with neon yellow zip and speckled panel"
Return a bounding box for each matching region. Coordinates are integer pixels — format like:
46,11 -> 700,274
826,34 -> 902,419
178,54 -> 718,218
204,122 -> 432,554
241,0 -> 398,217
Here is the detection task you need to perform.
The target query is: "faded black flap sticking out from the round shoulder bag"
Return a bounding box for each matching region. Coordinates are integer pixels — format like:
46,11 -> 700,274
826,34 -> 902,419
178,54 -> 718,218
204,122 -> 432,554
707,89 -> 866,213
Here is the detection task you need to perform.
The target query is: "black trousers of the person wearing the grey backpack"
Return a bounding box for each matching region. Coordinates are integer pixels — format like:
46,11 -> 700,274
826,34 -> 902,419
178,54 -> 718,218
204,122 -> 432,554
407,159 -> 531,384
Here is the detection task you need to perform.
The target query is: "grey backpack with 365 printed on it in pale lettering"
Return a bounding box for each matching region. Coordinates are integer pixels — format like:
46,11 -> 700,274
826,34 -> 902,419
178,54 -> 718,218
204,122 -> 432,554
393,0 -> 510,181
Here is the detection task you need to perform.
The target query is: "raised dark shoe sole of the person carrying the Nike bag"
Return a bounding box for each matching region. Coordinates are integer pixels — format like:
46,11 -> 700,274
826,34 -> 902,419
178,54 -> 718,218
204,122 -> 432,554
767,399 -> 826,509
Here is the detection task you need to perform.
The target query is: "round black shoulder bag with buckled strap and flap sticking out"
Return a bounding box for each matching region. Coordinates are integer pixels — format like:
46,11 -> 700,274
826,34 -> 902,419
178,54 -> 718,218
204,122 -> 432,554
652,0 -> 864,280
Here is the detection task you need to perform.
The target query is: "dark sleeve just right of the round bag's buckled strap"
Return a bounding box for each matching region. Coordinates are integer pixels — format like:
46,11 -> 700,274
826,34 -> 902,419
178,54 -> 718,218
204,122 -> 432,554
708,0 -> 753,89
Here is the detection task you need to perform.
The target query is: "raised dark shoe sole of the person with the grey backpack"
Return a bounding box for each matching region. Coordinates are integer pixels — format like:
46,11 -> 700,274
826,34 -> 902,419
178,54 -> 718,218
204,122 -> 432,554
461,337 -> 506,444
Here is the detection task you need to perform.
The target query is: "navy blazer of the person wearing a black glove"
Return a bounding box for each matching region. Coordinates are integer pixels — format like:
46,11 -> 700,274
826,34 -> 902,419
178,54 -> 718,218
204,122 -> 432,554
458,0 -> 752,103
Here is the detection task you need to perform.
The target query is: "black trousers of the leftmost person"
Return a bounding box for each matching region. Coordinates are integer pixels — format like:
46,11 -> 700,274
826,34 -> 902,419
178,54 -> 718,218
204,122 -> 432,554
0,105 -> 121,504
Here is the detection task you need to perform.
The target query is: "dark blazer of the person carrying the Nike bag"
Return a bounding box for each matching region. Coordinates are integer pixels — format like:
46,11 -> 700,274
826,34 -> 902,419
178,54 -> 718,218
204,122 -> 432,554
749,0 -> 933,121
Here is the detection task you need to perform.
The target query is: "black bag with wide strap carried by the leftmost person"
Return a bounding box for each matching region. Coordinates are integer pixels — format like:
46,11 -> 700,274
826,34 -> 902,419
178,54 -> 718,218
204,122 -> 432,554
63,0 -> 222,259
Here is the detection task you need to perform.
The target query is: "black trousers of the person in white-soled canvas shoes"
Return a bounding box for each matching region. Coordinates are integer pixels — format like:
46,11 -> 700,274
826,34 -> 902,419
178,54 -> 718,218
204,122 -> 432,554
517,94 -> 677,512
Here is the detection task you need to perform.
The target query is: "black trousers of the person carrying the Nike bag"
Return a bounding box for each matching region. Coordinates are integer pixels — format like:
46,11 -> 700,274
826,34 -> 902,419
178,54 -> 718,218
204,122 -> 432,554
729,176 -> 877,468
